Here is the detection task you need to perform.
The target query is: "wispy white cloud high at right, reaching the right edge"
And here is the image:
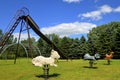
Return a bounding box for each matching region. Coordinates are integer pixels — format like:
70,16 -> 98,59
78,5 -> 120,20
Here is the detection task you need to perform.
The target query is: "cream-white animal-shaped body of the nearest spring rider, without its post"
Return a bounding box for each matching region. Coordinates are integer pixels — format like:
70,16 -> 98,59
32,49 -> 60,67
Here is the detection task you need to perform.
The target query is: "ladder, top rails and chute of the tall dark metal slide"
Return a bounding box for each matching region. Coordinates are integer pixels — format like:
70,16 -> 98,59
0,8 -> 67,58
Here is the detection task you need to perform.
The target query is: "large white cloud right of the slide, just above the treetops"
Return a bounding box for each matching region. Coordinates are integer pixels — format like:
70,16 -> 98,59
41,22 -> 96,37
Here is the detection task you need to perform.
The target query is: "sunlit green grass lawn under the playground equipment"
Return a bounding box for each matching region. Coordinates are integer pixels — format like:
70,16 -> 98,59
0,59 -> 120,80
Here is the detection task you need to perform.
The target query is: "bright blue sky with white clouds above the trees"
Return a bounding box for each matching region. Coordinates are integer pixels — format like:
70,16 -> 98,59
0,0 -> 120,39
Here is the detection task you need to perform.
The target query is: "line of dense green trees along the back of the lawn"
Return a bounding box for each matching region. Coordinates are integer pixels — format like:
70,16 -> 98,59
0,22 -> 120,59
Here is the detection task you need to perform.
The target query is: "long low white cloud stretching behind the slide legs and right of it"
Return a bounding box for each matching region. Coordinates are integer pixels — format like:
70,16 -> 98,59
13,22 -> 96,40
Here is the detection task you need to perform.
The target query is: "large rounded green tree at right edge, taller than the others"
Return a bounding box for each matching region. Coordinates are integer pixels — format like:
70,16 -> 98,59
88,22 -> 120,58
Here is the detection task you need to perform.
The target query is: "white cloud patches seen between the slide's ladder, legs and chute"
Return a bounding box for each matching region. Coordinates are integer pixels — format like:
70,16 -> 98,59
13,33 -> 38,40
